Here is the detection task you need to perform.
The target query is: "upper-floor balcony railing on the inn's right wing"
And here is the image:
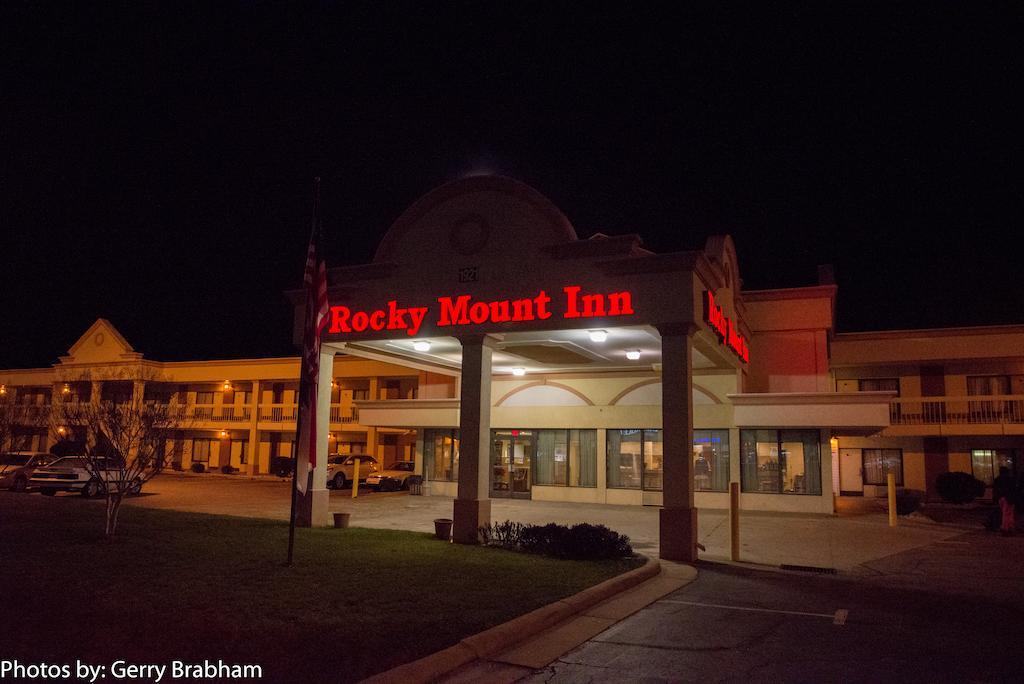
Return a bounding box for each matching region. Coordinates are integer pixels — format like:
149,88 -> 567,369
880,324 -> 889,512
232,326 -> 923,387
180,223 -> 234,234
889,394 -> 1024,425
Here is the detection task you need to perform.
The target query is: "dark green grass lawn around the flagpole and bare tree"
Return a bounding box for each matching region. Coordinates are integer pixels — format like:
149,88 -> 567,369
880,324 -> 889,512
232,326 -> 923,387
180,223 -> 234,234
0,491 -> 639,682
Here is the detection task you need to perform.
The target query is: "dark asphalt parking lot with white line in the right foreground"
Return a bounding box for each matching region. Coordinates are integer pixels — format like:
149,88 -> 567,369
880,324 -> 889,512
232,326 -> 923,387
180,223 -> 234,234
525,532 -> 1024,682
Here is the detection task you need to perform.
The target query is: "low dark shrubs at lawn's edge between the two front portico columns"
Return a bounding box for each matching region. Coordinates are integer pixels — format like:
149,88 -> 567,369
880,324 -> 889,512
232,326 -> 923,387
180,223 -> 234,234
480,520 -> 633,560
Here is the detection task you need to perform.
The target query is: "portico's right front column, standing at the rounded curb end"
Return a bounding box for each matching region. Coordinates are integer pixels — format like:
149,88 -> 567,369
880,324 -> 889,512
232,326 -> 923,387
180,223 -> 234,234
658,324 -> 697,562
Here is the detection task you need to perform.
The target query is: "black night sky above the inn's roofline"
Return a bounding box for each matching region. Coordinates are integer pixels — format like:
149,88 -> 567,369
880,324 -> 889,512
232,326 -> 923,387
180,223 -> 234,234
0,2 -> 1024,368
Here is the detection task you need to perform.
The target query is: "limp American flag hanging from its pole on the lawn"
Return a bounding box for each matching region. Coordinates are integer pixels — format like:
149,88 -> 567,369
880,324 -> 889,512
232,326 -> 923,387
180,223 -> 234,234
296,178 -> 330,494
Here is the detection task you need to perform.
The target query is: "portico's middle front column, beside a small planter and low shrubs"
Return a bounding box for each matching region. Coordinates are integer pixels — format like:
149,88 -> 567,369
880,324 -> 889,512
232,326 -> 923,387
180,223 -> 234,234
452,335 -> 494,544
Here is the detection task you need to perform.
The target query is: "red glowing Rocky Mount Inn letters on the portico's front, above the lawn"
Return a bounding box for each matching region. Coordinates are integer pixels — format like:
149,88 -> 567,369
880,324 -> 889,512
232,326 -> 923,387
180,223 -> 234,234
328,285 -> 634,336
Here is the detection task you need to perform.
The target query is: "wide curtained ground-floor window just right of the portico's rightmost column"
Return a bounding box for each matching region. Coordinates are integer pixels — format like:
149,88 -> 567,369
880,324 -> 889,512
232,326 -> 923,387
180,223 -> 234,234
739,430 -> 821,495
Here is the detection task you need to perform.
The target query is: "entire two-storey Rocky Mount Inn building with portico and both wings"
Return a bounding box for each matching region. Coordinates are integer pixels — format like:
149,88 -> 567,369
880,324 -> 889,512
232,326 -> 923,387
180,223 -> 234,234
0,177 -> 1024,559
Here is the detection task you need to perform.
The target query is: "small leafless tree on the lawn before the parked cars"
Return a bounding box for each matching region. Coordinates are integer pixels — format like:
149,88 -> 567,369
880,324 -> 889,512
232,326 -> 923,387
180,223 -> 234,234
50,369 -> 187,537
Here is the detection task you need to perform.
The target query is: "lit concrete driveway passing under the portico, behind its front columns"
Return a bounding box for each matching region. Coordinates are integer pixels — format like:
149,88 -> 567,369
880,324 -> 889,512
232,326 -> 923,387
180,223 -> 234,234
131,473 -> 958,574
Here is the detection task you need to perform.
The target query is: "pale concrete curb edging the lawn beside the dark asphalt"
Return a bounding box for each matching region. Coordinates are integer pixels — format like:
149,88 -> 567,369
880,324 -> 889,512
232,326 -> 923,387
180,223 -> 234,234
362,557 -> 662,684
